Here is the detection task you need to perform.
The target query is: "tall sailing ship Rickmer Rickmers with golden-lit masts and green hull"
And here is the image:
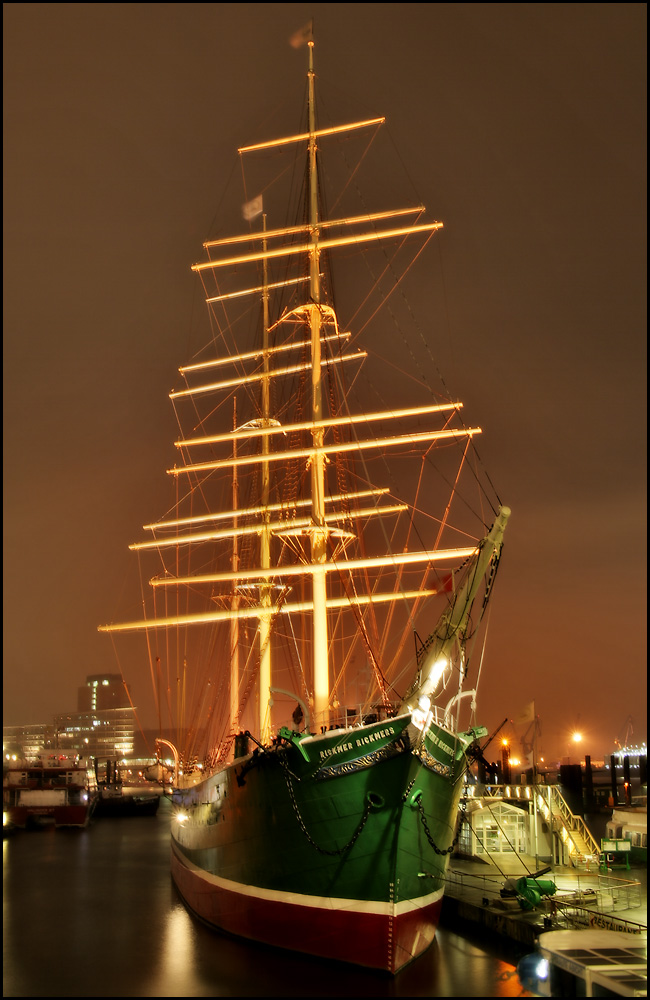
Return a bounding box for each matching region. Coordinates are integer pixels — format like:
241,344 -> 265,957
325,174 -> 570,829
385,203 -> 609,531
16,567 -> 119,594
102,38 -> 509,973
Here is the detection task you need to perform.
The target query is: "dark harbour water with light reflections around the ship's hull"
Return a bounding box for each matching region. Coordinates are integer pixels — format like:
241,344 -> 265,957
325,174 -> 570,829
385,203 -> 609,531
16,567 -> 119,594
3,800 -> 531,997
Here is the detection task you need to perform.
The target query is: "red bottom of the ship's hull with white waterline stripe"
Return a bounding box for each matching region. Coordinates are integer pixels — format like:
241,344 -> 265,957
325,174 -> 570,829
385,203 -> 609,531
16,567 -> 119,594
171,845 -> 442,973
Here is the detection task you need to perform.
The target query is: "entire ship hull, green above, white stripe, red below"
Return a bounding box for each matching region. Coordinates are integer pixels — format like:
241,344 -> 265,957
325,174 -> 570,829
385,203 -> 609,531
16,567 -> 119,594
172,715 -> 484,972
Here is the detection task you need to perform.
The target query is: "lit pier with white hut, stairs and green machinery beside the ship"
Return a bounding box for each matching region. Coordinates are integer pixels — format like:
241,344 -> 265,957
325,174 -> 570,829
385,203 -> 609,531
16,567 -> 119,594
441,785 -> 647,996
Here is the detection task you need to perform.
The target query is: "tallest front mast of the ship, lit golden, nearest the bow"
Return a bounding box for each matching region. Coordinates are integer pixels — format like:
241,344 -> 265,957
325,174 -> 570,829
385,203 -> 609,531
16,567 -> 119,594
308,39 -> 329,726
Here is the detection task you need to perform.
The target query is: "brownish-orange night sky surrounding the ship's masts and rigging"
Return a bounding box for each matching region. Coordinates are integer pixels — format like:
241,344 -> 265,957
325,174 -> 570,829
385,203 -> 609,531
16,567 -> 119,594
3,3 -> 647,758
